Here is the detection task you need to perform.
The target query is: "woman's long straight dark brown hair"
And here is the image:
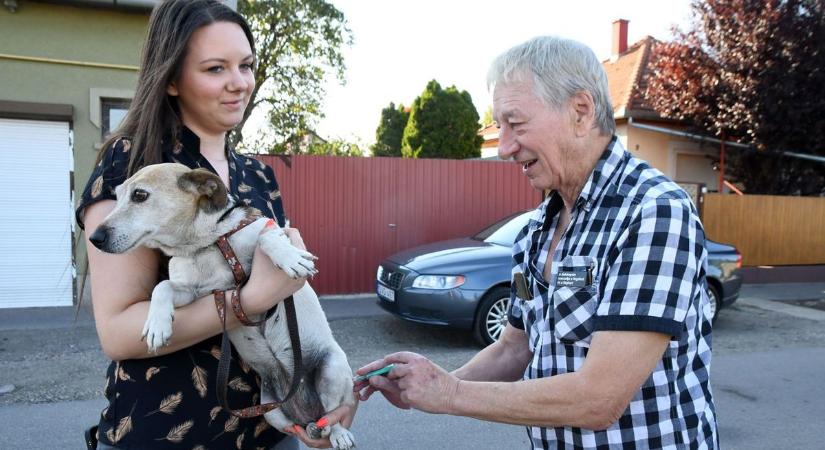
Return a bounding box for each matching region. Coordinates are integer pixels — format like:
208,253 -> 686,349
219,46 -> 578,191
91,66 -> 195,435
97,0 -> 255,175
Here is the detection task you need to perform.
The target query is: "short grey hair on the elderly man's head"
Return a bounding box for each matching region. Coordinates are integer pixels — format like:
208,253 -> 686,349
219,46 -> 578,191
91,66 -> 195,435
487,36 -> 616,136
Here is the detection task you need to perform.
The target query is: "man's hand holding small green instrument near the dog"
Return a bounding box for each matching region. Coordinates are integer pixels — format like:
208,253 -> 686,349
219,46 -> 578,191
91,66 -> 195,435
354,352 -> 459,413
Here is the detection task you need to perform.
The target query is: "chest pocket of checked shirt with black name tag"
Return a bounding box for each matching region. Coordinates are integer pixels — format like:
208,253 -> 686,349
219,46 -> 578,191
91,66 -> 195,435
553,256 -> 598,346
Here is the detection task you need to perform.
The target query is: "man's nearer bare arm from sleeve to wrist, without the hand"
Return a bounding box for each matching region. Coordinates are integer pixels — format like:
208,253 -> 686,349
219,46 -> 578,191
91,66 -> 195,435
444,331 -> 670,430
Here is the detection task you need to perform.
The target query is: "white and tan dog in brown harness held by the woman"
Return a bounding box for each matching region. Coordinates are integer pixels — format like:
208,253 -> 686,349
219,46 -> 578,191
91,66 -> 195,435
89,163 -> 355,450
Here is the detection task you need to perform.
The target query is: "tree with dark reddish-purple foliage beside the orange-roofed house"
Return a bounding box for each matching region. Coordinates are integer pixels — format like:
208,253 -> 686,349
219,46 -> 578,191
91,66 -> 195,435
646,0 -> 825,195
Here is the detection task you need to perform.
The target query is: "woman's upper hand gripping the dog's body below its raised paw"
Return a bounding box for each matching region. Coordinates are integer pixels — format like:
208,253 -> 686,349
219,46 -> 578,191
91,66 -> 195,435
241,228 -> 306,314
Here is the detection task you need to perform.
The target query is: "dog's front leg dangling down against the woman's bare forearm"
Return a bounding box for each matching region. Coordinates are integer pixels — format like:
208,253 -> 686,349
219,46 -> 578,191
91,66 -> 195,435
142,280 -> 194,353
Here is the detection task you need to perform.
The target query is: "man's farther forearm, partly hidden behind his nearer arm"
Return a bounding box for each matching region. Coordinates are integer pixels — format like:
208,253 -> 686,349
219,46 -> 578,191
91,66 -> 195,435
452,324 -> 533,381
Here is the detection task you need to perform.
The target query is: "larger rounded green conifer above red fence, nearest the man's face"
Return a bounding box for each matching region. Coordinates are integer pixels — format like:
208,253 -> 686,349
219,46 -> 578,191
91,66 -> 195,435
401,80 -> 483,159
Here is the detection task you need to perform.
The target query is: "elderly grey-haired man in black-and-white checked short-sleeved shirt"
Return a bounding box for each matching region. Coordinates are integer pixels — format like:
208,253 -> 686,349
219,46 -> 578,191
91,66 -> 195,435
355,37 -> 718,449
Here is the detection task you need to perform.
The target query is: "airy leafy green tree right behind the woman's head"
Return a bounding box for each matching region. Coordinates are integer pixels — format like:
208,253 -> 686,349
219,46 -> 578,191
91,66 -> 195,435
230,0 -> 352,153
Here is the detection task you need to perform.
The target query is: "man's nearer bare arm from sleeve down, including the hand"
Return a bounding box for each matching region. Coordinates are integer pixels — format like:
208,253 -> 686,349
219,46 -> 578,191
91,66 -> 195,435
376,331 -> 670,429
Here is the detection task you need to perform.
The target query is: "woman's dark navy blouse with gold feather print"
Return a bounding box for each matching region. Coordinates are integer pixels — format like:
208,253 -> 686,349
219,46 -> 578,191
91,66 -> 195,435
76,128 -> 285,449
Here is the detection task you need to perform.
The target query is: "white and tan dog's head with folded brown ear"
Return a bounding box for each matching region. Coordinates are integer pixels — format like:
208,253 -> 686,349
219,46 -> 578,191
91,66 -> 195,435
89,164 -> 228,253
